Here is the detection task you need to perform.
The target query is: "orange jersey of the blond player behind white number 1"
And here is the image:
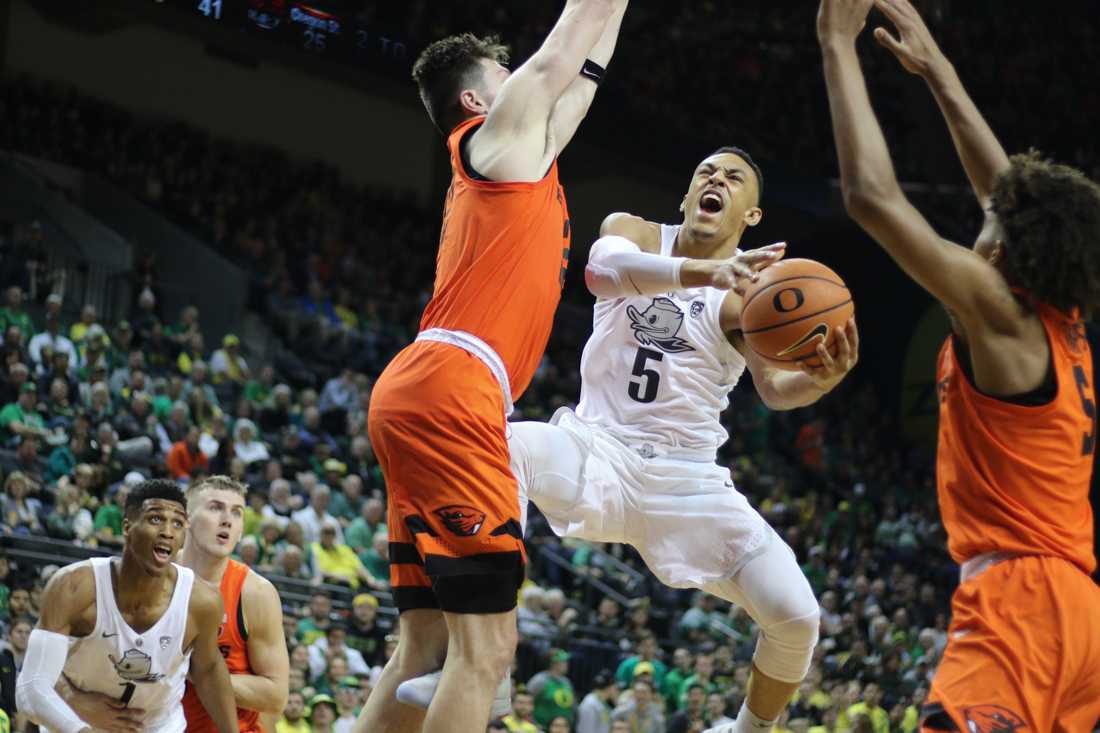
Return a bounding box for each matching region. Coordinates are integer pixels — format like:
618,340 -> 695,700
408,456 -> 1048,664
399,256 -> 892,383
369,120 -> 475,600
184,560 -> 261,733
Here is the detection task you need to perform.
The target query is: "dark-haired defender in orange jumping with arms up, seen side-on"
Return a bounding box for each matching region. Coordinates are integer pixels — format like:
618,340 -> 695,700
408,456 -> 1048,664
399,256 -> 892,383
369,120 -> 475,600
356,0 -> 627,733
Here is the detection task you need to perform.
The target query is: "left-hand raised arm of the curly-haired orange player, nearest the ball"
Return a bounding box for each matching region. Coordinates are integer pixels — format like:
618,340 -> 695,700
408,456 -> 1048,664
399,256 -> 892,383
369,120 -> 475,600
817,0 -> 1019,333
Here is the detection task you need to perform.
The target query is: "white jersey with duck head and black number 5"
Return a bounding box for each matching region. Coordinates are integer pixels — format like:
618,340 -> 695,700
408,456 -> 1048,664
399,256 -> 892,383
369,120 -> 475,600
576,225 -> 745,461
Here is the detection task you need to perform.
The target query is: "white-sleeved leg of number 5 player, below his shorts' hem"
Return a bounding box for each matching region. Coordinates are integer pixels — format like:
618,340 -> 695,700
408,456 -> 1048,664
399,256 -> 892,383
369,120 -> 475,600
703,536 -> 821,733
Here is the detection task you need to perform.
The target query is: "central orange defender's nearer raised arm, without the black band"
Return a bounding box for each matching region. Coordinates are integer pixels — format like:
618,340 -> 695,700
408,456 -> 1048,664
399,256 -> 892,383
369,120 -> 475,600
469,0 -> 616,182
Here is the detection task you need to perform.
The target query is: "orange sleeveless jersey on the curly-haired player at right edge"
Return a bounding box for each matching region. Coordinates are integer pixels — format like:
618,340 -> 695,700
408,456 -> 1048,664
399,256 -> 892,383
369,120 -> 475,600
936,304 -> 1096,573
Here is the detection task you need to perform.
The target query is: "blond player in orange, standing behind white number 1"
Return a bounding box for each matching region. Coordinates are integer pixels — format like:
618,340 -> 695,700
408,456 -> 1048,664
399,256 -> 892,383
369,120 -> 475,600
180,475 -> 289,733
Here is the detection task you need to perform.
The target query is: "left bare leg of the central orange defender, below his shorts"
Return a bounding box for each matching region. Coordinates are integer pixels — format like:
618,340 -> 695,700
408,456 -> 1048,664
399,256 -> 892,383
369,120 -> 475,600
353,609 -> 448,733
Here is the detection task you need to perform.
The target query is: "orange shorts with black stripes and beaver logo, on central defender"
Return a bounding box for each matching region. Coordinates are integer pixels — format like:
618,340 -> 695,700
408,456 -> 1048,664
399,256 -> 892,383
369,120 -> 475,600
369,341 -> 526,613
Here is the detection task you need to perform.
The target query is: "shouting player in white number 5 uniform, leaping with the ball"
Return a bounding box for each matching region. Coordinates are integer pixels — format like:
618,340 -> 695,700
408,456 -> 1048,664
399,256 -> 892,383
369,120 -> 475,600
402,147 -> 858,733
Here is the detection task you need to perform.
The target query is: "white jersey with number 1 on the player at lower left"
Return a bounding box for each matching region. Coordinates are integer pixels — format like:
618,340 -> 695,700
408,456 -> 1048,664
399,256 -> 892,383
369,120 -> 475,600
64,557 -> 195,733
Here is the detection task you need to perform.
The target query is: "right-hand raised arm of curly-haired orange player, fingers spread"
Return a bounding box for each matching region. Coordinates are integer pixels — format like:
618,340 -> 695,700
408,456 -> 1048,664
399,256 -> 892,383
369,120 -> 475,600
875,0 -> 1009,203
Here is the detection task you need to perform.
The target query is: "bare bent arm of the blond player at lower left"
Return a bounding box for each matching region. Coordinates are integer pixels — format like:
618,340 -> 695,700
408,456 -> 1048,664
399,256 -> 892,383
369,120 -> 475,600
230,573 -> 290,714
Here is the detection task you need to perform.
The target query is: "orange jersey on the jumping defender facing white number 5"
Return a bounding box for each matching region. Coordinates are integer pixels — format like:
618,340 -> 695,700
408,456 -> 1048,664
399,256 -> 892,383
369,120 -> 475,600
420,117 -> 570,400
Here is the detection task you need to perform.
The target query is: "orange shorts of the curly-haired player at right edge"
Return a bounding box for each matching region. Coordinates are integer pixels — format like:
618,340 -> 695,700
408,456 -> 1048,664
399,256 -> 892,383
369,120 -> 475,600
922,556 -> 1100,733
